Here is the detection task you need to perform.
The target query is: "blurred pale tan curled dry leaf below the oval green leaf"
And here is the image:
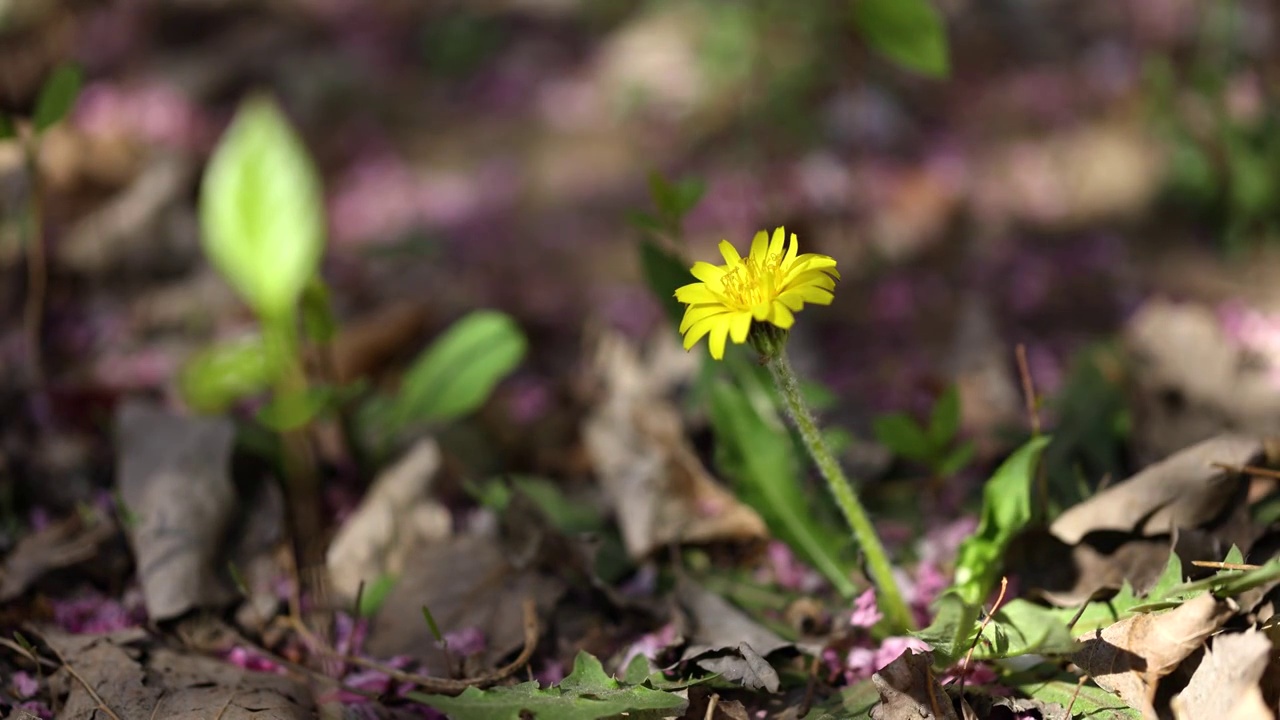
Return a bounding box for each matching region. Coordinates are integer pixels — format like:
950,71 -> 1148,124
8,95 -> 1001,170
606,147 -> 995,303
325,438 -> 453,601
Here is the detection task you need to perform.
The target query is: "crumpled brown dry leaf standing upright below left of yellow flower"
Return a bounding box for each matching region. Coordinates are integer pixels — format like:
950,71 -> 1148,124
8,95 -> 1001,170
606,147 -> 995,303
582,333 -> 768,559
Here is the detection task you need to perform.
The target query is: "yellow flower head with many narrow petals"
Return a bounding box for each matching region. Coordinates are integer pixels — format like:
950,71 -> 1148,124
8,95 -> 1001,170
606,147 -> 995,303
676,228 -> 840,360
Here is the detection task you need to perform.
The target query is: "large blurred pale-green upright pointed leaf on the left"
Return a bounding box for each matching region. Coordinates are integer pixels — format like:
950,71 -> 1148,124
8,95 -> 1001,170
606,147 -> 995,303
200,97 -> 325,319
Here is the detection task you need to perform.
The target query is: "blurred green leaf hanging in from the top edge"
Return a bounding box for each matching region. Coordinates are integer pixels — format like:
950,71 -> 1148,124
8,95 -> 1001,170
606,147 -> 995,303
854,0 -> 951,78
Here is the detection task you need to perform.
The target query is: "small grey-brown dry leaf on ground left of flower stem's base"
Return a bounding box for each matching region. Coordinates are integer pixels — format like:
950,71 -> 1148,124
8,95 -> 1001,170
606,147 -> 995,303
676,582 -> 792,693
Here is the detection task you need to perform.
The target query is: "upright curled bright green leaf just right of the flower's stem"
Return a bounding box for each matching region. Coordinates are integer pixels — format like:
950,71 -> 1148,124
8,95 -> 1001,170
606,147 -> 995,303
952,436 -> 1050,605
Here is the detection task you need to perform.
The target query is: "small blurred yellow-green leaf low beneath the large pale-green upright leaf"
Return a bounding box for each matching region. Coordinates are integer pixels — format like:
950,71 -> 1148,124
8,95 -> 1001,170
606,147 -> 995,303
178,334 -> 274,414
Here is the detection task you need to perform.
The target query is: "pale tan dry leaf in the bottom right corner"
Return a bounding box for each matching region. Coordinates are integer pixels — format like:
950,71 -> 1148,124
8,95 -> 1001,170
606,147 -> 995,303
1172,628 -> 1275,720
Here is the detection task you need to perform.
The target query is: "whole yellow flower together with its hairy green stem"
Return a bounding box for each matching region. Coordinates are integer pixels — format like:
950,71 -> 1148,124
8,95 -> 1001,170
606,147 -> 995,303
676,228 -> 915,632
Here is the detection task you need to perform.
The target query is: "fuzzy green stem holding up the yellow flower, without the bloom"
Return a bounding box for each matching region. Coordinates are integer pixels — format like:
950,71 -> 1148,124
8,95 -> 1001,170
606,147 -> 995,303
765,343 -> 915,632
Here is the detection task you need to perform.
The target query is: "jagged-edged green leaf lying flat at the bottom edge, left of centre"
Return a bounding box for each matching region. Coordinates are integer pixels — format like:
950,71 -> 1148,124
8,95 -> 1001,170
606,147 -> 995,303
408,652 -> 689,720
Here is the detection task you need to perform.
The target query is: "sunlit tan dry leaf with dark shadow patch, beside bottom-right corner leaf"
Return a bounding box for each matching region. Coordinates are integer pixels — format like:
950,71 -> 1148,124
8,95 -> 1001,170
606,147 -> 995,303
1071,593 -> 1236,717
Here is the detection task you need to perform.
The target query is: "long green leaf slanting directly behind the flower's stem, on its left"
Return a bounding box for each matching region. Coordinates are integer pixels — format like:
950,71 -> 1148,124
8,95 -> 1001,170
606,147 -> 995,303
707,377 -> 855,597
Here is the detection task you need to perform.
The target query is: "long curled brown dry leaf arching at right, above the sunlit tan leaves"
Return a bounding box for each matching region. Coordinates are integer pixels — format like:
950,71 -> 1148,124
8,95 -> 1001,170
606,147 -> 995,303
1050,434 -> 1263,544
